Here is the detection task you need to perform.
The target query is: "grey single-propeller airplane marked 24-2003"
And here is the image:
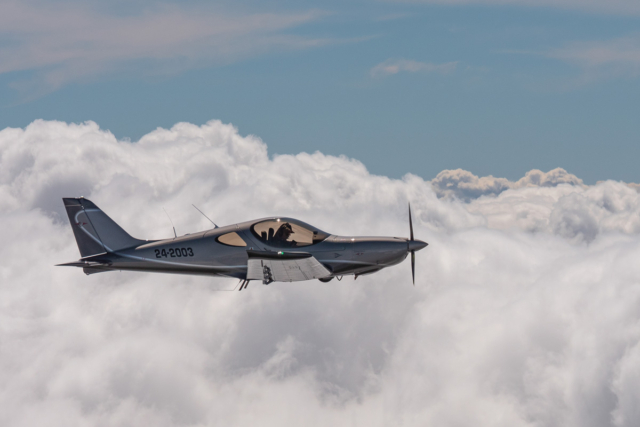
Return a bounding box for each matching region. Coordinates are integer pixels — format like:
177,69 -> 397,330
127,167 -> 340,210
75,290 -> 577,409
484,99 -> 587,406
58,197 -> 428,291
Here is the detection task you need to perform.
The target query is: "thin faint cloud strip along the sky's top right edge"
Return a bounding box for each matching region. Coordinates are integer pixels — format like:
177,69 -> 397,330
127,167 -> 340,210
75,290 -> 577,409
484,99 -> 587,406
401,0 -> 640,15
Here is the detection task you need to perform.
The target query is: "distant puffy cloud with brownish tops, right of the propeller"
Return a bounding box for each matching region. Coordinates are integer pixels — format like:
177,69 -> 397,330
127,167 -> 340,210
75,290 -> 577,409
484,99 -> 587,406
431,168 -> 640,243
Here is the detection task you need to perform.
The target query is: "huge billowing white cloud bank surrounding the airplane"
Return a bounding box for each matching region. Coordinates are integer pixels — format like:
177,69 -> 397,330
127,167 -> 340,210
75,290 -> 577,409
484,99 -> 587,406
0,120 -> 640,427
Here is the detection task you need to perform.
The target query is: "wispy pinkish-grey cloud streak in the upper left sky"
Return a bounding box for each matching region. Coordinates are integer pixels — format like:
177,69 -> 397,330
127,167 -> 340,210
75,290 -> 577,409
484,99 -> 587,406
0,1 -> 329,96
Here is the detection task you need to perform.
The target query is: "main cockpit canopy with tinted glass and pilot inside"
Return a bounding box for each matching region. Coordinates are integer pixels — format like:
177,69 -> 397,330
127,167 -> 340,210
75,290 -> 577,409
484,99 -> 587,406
251,218 -> 329,248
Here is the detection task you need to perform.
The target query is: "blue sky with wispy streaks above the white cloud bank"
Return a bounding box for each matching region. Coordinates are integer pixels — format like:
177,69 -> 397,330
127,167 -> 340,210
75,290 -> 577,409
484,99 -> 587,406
0,0 -> 640,183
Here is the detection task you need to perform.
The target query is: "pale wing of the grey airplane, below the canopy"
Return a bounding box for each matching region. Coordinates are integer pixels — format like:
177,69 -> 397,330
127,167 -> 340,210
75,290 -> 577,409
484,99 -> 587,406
247,250 -> 331,284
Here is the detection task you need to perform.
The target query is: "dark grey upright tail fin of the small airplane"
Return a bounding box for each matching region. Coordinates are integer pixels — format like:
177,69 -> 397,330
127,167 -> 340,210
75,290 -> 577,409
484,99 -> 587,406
62,197 -> 144,258
